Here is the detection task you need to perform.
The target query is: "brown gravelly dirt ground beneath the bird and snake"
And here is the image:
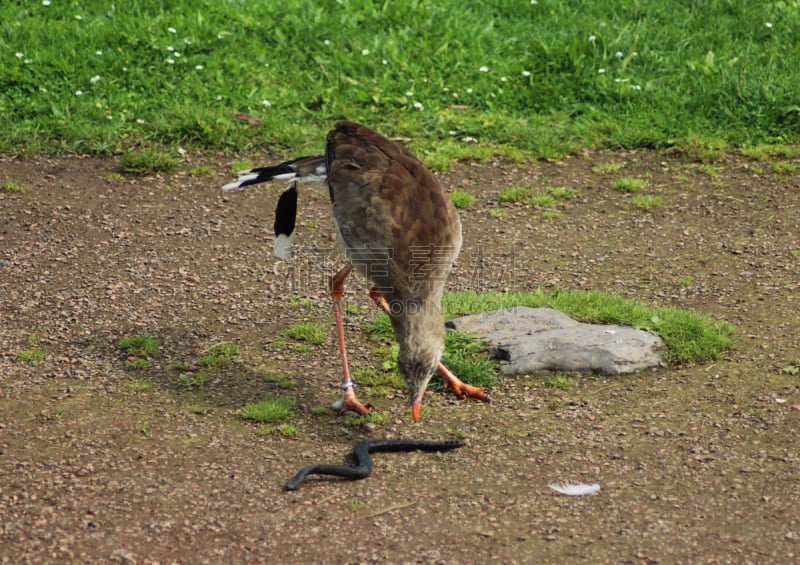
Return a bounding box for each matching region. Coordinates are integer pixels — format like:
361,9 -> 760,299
0,147 -> 800,563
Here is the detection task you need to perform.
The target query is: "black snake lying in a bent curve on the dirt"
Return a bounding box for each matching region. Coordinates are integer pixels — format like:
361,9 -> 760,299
284,439 -> 464,490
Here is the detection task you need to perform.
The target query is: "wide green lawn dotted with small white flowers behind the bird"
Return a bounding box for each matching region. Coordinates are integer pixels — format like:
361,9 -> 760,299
0,0 -> 800,159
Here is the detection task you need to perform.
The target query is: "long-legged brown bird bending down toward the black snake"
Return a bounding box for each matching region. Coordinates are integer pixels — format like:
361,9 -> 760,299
222,121 -> 490,422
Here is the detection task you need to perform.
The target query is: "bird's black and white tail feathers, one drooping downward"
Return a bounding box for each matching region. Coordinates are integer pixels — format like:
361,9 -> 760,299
222,155 -> 328,262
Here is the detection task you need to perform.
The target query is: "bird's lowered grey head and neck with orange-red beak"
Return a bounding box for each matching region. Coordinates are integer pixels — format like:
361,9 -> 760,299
393,305 -> 444,422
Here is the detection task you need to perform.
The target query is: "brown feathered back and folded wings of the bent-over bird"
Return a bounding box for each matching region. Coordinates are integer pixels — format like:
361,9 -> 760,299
326,122 -> 461,299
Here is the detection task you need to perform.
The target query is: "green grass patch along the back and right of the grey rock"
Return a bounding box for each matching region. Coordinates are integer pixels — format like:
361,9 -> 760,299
443,290 -> 735,363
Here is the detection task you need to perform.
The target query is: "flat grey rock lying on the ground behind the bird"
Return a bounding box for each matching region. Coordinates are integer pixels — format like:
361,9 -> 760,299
447,306 -> 664,375
